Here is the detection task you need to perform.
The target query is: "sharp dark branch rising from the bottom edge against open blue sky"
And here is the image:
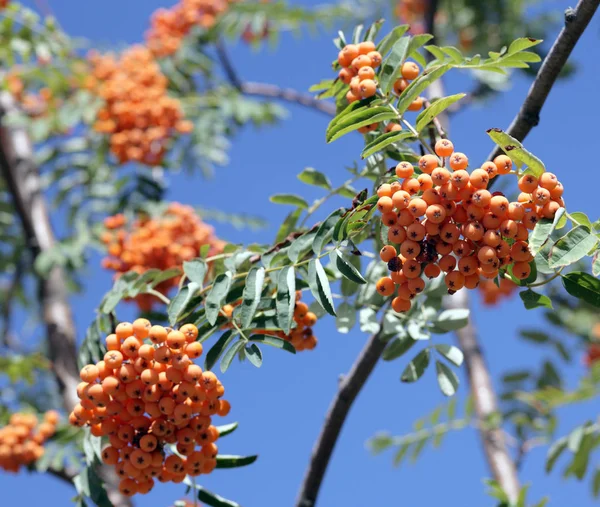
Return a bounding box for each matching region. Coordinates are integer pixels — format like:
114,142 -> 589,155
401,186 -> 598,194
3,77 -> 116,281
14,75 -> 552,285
296,326 -> 386,507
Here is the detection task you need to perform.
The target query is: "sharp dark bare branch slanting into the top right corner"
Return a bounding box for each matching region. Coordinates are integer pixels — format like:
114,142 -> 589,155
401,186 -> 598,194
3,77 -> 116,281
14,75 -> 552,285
488,0 -> 600,160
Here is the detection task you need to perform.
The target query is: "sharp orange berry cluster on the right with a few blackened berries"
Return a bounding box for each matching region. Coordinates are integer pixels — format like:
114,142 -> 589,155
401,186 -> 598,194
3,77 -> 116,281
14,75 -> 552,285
377,139 -> 564,312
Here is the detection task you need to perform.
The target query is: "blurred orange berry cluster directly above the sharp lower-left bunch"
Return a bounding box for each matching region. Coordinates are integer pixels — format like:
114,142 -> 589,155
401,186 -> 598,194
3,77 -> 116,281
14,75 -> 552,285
101,203 -> 225,311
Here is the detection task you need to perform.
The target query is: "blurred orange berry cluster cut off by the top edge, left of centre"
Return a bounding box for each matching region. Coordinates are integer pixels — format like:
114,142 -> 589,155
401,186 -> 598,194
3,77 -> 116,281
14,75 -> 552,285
146,0 -> 235,57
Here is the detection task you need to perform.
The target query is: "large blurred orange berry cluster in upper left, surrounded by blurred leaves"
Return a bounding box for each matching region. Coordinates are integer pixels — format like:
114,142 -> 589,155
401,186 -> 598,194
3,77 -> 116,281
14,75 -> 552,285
86,46 -> 193,165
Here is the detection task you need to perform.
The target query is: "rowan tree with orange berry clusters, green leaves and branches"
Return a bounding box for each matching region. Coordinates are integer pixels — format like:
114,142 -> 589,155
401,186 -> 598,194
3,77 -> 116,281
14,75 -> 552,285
0,0 -> 600,507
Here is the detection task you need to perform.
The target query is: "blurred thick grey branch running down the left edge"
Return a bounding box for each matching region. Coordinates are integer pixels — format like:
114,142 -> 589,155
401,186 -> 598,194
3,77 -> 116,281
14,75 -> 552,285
0,92 -> 132,507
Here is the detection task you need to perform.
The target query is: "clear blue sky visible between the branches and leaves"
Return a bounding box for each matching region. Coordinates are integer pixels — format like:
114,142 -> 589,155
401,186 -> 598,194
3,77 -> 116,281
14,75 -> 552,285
0,0 -> 600,507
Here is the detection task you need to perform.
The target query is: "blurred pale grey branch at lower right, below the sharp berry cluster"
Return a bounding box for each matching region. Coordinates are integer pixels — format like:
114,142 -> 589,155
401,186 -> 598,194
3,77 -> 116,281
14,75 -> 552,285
445,290 -> 521,501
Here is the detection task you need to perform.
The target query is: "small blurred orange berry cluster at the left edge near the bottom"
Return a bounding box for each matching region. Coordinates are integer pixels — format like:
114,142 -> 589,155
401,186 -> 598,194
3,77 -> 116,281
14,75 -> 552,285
0,410 -> 59,473
